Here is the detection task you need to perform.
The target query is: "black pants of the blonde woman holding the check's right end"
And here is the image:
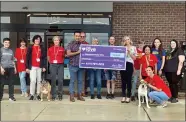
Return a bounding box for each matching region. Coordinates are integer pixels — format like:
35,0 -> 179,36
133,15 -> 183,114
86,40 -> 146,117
120,62 -> 133,98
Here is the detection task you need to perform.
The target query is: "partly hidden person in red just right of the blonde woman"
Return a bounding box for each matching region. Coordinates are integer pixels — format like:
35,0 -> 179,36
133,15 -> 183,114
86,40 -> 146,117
131,40 -> 144,101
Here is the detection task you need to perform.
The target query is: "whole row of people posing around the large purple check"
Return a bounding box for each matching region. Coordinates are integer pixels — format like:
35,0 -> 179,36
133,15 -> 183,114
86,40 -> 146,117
0,31 -> 185,107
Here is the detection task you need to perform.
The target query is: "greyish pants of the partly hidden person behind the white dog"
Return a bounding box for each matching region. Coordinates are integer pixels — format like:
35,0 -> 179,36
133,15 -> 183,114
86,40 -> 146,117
132,70 -> 140,96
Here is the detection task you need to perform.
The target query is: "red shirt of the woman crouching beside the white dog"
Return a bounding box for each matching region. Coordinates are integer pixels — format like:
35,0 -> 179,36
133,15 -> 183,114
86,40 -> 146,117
145,75 -> 172,98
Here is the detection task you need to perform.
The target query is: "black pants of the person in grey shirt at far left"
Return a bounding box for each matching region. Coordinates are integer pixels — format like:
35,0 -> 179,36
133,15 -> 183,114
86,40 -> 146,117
0,68 -> 15,99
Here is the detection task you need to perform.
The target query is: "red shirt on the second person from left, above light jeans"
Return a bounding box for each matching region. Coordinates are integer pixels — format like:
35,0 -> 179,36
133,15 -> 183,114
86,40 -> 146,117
15,48 -> 27,72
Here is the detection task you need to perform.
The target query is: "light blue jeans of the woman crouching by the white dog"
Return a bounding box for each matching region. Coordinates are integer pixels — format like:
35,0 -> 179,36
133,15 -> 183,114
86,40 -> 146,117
149,91 -> 169,104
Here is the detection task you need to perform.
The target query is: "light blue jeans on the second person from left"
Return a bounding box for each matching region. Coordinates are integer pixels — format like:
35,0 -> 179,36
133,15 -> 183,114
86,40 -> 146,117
19,72 -> 27,92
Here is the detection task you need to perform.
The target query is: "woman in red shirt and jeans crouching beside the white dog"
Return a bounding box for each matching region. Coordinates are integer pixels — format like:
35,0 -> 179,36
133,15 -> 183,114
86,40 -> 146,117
145,66 -> 171,108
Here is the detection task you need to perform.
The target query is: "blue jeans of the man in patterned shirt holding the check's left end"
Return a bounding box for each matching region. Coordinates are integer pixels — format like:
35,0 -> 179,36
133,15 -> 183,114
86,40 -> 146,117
69,65 -> 84,94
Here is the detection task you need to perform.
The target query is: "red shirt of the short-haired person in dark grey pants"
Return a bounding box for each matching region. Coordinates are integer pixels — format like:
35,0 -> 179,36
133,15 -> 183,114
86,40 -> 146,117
48,46 -> 65,64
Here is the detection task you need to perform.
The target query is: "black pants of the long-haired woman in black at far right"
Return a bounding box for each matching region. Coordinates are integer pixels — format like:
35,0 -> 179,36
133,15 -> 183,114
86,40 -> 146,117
165,72 -> 181,98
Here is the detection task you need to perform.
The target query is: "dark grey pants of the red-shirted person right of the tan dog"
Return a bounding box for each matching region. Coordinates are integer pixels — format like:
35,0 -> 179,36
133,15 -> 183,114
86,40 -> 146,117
50,64 -> 64,98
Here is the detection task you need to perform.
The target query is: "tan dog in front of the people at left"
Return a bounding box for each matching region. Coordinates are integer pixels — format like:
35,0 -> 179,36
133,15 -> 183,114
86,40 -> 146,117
41,81 -> 51,101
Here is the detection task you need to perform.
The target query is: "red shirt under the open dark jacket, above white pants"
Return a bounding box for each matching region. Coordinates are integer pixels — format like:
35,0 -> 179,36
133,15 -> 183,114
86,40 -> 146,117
32,46 -> 41,67
